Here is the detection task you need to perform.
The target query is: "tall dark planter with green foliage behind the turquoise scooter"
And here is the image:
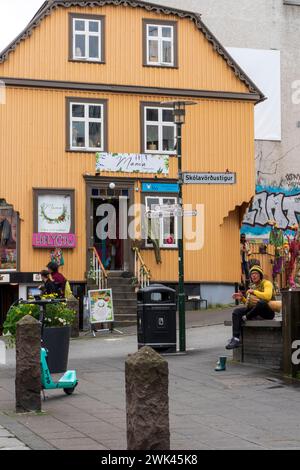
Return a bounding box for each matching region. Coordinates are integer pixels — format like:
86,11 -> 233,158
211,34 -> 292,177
3,294 -> 76,374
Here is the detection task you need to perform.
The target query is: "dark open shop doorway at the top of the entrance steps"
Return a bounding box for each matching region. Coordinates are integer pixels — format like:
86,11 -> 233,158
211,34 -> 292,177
93,197 -> 124,271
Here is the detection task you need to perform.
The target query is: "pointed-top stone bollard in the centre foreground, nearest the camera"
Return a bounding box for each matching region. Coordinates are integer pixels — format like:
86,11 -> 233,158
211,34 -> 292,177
125,346 -> 170,450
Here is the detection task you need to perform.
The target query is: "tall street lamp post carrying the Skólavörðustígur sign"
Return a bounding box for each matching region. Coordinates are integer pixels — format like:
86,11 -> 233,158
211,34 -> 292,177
163,101 -> 197,352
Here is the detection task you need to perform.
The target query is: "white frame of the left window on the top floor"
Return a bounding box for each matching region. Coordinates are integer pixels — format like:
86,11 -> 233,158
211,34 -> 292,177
72,18 -> 103,62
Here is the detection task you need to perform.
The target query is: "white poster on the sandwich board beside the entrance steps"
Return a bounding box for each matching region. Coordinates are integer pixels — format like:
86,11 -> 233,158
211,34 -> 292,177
89,289 -> 114,324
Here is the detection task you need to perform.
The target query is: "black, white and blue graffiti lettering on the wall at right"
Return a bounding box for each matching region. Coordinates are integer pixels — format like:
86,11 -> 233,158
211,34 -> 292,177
242,186 -> 300,238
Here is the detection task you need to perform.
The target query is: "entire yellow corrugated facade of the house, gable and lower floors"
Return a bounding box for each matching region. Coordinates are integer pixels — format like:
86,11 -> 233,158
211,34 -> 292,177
0,2 -> 255,282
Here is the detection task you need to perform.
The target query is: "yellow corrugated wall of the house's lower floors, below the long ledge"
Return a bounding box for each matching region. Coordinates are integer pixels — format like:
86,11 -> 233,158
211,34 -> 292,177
0,88 -> 254,281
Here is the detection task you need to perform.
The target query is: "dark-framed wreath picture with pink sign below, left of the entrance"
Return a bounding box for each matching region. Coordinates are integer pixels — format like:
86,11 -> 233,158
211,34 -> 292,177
32,189 -> 76,249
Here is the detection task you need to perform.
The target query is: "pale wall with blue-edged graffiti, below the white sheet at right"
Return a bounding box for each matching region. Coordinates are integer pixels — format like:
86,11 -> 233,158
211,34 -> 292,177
241,139 -> 300,241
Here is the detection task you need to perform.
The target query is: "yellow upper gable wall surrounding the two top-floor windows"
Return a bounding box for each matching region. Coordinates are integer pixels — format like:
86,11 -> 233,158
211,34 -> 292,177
0,6 -> 249,93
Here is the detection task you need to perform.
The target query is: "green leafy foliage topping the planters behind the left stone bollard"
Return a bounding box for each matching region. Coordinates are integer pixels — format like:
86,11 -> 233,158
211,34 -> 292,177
3,303 -> 76,346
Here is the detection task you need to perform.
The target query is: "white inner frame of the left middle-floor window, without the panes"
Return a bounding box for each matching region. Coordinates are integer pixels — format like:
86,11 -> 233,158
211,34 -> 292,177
69,101 -> 105,152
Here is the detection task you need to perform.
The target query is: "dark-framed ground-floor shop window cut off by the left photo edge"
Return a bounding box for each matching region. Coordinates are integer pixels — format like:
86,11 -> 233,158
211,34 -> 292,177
0,206 -> 18,271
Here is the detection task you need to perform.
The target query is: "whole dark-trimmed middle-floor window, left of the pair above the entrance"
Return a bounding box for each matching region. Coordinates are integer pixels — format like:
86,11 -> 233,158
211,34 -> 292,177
68,100 -> 106,151
